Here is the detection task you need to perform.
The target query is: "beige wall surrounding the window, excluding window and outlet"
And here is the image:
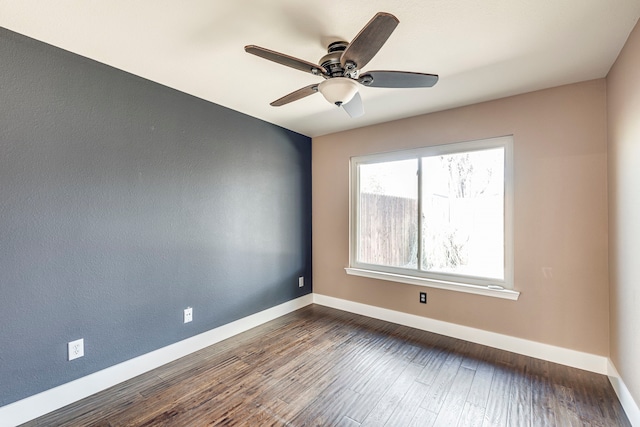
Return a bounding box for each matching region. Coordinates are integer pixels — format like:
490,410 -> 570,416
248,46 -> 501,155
312,77 -> 608,356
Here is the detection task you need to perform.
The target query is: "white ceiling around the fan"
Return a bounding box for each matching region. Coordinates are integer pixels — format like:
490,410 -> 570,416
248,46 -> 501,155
0,0 -> 640,137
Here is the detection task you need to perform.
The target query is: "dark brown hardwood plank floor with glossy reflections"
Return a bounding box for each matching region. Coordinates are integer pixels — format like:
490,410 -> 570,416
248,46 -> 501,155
23,305 -> 630,427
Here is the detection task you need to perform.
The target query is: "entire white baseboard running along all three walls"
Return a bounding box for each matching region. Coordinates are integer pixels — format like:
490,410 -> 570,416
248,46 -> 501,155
0,294 -> 624,427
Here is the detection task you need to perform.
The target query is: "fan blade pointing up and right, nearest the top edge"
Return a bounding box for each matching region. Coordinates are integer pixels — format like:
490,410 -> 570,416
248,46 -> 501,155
340,12 -> 400,69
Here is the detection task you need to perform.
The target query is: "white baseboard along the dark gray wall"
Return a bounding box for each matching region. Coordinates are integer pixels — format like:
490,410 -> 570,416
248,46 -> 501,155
0,294 -> 313,427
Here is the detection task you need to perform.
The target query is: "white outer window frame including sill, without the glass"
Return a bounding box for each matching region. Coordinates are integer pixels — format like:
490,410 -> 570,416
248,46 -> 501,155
345,135 -> 520,300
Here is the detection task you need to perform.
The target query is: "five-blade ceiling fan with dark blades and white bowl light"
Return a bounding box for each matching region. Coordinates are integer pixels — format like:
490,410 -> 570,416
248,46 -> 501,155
244,12 -> 438,117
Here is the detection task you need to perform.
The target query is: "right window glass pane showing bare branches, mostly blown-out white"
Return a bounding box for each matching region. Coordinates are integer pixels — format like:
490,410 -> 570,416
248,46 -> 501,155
421,148 -> 504,280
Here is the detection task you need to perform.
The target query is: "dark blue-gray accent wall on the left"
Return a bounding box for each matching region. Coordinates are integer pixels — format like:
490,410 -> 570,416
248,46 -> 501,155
0,29 -> 311,406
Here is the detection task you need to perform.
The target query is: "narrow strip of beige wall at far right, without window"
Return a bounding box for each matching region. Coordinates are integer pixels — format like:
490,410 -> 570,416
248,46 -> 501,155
607,20 -> 640,404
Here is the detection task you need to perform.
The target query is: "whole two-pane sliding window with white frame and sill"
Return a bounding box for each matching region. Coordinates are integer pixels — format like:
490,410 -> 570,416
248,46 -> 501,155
347,136 -> 518,299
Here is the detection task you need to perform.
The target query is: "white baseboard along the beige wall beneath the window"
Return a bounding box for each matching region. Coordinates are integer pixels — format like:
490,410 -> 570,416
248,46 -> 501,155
313,293 -> 607,375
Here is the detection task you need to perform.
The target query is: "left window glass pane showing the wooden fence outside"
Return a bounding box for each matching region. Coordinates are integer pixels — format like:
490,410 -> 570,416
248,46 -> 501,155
357,159 -> 418,268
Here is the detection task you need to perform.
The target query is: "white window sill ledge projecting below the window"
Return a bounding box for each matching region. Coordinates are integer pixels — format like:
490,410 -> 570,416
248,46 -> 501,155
345,267 -> 520,301
